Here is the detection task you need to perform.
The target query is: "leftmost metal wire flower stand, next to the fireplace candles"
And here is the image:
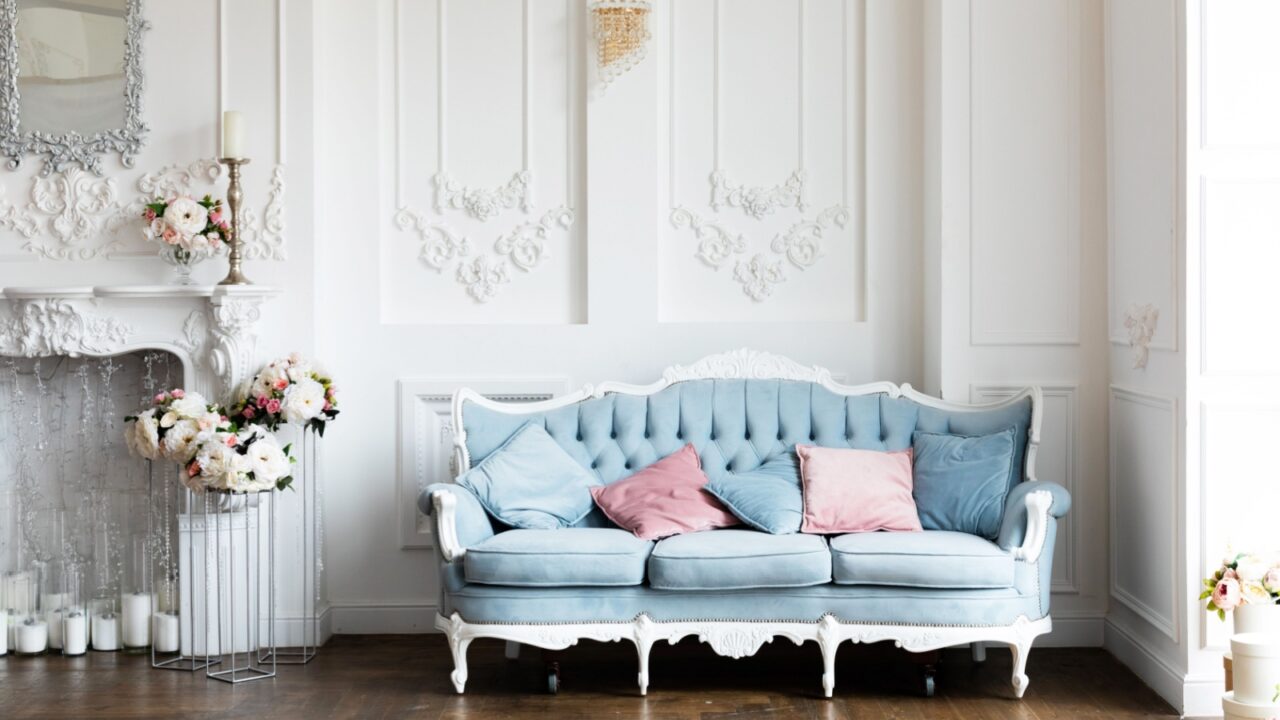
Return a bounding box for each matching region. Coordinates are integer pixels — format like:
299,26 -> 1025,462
147,460 -> 221,673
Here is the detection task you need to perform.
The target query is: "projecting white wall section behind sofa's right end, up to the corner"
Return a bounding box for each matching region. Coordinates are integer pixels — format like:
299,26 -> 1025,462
924,0 -> 1108,644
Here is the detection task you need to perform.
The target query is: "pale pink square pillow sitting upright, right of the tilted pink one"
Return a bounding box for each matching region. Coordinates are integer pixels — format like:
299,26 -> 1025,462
798,445 -> 920,534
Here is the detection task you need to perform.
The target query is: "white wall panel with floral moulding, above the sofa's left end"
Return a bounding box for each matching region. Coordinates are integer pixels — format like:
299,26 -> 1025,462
379,0 -> 586,324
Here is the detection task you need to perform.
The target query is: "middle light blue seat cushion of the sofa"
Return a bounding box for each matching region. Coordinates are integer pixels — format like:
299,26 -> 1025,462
649,530 -> 831,591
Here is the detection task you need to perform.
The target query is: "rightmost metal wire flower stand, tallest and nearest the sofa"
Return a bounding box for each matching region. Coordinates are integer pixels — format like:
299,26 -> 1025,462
257,429 -> 320,665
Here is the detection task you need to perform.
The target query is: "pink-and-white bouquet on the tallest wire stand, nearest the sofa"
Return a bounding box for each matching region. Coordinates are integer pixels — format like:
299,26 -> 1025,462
230,352 -> 338,437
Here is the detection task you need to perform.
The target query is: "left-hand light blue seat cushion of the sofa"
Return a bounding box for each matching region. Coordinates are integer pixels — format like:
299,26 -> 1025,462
463,528 -> 653,587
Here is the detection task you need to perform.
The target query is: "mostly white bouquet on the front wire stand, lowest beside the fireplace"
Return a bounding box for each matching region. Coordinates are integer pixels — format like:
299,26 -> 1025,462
186,425 -> 294,493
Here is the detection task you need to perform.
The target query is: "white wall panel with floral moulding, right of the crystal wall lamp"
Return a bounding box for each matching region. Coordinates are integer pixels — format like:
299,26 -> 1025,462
659,0 -> 865,322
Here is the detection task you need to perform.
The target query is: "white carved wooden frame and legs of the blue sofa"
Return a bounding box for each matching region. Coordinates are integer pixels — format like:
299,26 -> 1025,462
431,350 -> 1052,698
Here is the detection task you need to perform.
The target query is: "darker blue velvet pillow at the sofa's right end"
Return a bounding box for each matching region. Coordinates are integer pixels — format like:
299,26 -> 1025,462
911,428 -> 1015,539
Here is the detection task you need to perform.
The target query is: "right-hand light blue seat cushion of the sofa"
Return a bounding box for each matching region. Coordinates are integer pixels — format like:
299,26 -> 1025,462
831,530 -> 1014,589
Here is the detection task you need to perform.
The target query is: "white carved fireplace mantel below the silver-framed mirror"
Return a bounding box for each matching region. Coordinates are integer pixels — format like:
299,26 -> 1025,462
0,286 -> 280,400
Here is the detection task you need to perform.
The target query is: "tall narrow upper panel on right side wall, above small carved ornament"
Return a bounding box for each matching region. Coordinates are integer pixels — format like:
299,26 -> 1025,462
1106,0 -> 1180,350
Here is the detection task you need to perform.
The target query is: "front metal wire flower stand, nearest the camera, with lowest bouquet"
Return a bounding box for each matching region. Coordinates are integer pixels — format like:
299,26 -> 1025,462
204,488 -> 275,684
